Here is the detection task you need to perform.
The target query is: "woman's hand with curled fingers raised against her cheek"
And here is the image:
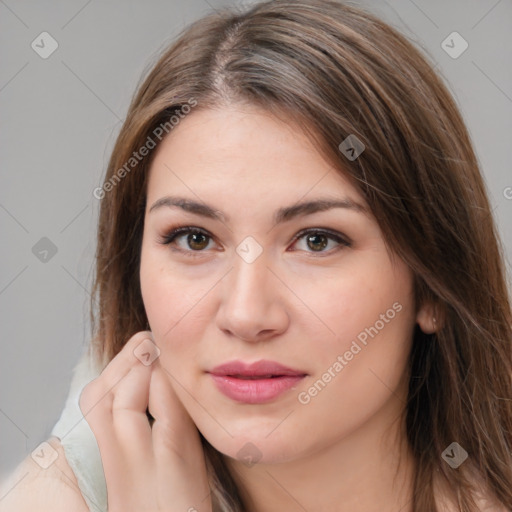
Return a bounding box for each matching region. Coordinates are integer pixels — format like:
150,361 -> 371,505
79,331 -> 212,512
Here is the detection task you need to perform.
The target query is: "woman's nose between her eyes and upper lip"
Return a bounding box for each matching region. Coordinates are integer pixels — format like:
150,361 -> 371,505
217,253 -> 289,342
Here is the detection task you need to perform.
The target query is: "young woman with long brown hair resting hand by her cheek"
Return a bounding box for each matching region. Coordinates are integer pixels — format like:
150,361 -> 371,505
2,0 -> 512,512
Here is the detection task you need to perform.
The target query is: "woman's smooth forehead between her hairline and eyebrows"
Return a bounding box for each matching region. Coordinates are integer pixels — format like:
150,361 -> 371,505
148,106 -> 363,209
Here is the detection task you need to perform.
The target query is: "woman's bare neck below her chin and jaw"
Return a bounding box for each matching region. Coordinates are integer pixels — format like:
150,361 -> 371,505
225,398 -> 414,512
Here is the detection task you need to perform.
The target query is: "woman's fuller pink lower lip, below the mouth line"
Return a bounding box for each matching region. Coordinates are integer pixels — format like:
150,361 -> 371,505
210,374 -> 304,404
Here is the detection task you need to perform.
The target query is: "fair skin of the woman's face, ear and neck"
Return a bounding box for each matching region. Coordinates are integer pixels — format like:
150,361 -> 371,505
136,106 -> 432,512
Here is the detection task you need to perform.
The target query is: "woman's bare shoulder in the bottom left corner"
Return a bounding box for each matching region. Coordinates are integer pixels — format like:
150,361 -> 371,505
0,437 -> 89,512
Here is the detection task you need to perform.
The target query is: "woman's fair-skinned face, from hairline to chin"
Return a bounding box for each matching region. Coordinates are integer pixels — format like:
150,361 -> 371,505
140,106 -> 424,462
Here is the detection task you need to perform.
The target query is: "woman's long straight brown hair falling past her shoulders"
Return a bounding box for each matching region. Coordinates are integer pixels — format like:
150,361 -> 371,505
91,0 -> 512,512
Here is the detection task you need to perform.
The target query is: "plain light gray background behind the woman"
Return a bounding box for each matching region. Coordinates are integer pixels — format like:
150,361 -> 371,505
0,0 -> 512,480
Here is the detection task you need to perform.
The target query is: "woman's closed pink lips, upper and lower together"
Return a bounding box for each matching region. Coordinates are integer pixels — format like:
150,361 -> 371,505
208,360 -> 307,404
